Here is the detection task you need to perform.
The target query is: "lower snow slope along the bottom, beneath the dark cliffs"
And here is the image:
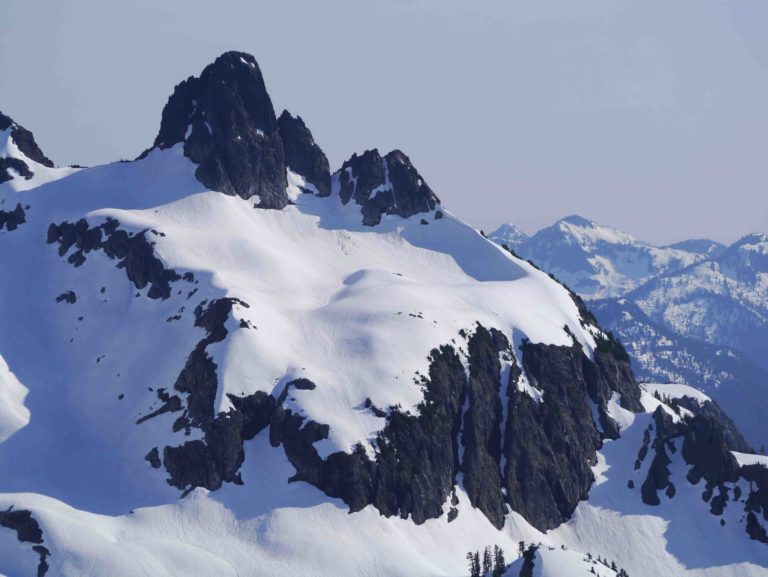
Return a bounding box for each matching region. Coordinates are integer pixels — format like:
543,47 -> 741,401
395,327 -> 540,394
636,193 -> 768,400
0,376 -> 768,577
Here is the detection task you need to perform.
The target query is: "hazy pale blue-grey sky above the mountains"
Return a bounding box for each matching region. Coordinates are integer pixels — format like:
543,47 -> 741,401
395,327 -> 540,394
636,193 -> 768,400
0,0 -> 768,242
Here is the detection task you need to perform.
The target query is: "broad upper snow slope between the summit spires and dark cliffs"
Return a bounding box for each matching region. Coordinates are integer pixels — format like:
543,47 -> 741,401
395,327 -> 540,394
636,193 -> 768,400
0,141 -> 594,513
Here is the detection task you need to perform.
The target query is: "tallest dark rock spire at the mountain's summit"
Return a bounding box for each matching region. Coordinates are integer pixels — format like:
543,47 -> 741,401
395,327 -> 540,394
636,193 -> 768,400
148,52 -> 288,209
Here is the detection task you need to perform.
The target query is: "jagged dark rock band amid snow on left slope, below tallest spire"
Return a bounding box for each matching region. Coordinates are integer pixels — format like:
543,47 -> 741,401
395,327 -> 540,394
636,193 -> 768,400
48,218 -> 194,299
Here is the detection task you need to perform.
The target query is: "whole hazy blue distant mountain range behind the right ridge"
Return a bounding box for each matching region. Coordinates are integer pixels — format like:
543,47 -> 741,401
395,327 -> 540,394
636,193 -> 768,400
489,216 -> 768,446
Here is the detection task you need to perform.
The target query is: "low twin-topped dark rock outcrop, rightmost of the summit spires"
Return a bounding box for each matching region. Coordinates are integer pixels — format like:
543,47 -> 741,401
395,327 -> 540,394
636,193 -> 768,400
337,149 -> 440,226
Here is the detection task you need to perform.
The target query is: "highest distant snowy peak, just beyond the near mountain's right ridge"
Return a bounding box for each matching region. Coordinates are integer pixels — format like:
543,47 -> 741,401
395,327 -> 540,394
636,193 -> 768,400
517,215 -> 705,299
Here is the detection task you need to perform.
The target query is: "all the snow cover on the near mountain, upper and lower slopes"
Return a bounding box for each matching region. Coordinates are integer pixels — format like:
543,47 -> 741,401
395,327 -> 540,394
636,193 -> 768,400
0,118 -> 768,577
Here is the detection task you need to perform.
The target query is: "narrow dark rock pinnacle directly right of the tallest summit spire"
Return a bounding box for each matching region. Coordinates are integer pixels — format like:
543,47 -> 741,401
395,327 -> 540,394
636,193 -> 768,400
277,110 -> 331,196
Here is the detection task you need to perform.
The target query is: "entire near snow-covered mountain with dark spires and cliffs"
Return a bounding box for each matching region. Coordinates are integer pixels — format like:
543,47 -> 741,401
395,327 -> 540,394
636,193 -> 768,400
0,52 -> 768,577
